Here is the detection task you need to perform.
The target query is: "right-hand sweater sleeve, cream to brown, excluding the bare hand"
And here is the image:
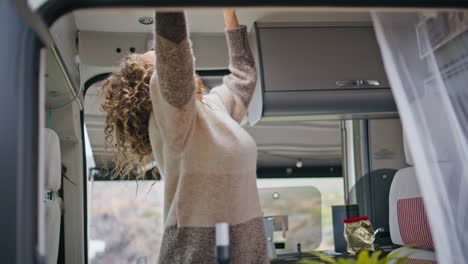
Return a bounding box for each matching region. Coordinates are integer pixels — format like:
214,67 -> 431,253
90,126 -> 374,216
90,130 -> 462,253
211,25 -> 257,122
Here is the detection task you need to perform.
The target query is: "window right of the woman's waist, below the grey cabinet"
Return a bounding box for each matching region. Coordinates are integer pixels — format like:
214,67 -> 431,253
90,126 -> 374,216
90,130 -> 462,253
257,178 -> 344,253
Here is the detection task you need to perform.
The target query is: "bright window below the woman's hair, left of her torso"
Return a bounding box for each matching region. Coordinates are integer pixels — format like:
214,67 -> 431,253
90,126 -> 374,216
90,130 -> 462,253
88,181 -> 163,264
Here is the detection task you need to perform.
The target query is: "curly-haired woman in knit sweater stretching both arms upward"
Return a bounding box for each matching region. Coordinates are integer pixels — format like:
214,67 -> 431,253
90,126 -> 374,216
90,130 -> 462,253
103,10 -> 268,264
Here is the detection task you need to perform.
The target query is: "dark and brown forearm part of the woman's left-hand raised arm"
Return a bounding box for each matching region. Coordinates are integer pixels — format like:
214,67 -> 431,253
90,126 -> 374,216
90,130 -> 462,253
154,12 -> 196,108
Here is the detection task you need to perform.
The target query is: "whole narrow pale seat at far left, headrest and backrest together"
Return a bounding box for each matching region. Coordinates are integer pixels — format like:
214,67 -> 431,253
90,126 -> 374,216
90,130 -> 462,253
43,128 -> 62,264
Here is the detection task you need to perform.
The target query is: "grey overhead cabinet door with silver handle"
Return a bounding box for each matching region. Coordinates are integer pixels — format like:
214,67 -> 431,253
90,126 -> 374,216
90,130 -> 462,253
258,26 -> 389,91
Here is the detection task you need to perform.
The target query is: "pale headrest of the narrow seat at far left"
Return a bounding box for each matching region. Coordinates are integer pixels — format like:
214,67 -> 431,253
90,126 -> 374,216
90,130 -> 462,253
44,128 -> 62,191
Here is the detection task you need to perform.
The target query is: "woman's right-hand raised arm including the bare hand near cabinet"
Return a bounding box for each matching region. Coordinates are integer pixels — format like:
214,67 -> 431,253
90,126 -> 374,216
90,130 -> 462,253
223,9 -> 257,107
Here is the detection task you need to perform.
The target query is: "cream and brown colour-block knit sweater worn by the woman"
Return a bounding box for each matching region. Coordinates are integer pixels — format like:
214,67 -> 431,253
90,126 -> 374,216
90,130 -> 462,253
149,13 -> 268,263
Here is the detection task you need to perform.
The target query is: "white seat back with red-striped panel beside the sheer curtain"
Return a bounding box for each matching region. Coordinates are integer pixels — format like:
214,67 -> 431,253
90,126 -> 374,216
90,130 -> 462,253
389,167 -> 434,249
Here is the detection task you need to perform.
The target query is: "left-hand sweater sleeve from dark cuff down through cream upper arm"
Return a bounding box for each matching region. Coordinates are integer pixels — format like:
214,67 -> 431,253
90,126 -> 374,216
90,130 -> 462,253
150,12 -> 196,149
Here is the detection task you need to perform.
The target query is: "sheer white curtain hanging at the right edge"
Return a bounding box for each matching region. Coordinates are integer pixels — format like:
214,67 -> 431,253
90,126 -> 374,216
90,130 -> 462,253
372,11 -> 468,264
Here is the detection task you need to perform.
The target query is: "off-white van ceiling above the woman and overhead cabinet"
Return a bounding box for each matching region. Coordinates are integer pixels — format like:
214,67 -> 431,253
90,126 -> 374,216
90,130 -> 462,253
74,8 -> 371,33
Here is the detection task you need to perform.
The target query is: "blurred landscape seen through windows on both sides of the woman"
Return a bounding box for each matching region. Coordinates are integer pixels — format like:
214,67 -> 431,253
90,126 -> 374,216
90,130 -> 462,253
88,178 -> 344,264
